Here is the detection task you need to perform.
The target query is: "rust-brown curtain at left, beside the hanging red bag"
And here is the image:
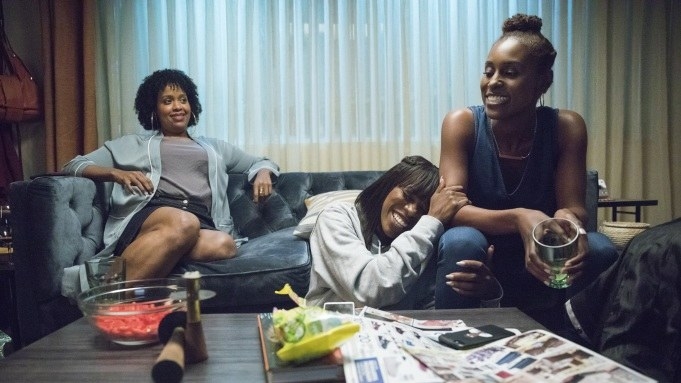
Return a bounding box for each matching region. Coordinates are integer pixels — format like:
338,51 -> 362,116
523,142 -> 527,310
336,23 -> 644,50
40,0 -> 97,171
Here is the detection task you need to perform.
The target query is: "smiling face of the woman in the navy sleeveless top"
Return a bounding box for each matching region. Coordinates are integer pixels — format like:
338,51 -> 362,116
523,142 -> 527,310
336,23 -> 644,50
480,37 -> 545,119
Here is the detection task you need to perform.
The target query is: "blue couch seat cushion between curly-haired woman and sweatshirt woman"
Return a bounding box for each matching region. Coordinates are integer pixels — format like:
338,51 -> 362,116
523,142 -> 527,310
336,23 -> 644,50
173,227 -> 310,308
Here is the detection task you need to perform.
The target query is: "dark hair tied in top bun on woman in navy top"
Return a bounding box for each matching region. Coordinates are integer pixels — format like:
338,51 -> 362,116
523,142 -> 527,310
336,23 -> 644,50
495,13 -> 557,89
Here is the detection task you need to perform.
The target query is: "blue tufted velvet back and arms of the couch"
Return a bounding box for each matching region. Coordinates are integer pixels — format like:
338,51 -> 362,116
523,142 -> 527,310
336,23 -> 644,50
10,171 -> 598,344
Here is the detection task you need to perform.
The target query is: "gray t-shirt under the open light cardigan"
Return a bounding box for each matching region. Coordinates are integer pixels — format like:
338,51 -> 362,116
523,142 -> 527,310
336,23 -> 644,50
158,137 -> 211,212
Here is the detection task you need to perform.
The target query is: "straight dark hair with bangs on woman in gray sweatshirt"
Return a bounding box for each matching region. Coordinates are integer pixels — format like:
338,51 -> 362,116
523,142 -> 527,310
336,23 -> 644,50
355,156 -> 440,249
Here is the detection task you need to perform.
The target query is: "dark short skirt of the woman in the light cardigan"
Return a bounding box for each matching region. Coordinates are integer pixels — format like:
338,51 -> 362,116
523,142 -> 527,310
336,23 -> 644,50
113,193 -> 216,256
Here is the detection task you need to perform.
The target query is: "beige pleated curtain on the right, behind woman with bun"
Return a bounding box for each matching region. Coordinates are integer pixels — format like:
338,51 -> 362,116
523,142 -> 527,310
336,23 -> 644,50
574,0 -> 681,224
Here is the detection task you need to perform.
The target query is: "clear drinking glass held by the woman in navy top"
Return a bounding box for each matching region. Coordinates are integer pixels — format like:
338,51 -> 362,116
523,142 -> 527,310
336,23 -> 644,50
532,218 -> 579,289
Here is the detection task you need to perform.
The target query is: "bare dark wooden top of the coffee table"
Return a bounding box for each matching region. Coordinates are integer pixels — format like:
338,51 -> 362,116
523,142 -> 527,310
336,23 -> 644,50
0,308 -> 544,383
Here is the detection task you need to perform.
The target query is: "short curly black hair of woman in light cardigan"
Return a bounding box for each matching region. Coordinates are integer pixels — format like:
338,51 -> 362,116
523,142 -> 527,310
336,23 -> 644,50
135,69 -> 203,130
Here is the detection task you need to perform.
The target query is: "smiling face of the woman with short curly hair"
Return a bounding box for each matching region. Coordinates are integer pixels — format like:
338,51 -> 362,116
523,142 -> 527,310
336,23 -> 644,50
156,85 -> 192,137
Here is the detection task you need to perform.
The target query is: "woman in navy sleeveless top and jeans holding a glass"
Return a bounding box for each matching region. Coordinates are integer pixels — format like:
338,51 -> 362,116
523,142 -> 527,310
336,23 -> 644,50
435,14 -> 618,327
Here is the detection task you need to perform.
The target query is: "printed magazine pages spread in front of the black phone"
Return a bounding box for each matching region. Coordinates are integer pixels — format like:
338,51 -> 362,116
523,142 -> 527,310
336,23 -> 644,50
374,324 -> 655,383
